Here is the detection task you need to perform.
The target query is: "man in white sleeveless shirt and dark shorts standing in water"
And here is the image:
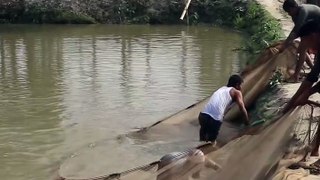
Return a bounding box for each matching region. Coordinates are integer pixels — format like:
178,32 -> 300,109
198,75 -> 249,142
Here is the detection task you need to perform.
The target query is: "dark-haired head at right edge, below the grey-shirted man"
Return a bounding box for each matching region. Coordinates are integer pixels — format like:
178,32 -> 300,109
297,20 -> 320,50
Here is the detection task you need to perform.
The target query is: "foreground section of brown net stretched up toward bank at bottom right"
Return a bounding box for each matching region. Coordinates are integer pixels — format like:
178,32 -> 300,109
120,108 -> 316,180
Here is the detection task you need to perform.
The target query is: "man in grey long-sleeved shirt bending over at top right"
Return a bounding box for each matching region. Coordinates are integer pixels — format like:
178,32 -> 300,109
279,0 -> 320,82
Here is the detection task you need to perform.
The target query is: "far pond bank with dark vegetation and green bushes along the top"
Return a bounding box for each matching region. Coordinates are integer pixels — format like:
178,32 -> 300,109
0,0 -> 283,57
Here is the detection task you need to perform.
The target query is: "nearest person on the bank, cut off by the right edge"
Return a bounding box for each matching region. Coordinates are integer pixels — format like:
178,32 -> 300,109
283,20 -> 320,159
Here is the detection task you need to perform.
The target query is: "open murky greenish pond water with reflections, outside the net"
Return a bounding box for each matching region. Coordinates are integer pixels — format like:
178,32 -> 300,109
0,25 -> 248,180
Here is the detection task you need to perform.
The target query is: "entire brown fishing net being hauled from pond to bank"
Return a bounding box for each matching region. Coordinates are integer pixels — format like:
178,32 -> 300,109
60,42 -> 315,180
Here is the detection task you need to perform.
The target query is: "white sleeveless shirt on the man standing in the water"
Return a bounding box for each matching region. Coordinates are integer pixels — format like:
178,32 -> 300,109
202,86 -> 233,122
